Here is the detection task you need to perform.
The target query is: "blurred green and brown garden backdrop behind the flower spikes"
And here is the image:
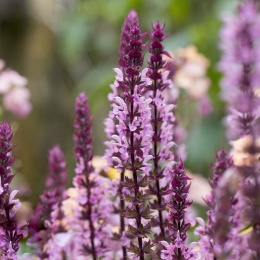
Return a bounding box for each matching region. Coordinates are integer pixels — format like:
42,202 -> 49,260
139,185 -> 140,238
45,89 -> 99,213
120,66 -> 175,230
0,0 -> 237,204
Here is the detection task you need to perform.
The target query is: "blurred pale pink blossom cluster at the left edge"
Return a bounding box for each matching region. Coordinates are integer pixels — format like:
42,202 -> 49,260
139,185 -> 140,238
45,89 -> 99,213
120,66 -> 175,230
0,60 -> 32,117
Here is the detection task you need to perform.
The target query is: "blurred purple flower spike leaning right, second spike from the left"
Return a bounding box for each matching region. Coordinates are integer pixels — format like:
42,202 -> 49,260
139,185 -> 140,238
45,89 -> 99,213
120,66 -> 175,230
29,146 -> 67,258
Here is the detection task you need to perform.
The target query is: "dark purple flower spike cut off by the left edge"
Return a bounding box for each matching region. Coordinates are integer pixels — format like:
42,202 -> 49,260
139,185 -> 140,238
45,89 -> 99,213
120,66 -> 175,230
0,122 -> 27,260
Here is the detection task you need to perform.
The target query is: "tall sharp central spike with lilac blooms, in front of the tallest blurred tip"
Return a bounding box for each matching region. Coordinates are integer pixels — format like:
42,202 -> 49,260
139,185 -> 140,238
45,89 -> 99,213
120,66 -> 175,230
112,25 -> 153,260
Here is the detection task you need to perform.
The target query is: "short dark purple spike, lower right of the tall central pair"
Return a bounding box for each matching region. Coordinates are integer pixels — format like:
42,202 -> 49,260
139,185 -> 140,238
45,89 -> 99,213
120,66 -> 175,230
161,161 -> 198,260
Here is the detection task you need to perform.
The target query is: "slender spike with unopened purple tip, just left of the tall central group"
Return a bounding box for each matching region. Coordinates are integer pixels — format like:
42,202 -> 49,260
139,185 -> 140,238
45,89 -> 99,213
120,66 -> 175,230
73,93 -> 98,260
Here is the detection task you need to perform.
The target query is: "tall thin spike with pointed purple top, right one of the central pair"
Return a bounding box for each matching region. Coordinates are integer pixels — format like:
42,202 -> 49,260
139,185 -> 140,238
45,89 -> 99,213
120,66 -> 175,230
147,22 -> 174,243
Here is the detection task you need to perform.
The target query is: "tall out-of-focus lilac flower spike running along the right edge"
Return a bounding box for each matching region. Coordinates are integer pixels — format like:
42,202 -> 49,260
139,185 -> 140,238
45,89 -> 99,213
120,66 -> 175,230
220,0 -> 260,258
